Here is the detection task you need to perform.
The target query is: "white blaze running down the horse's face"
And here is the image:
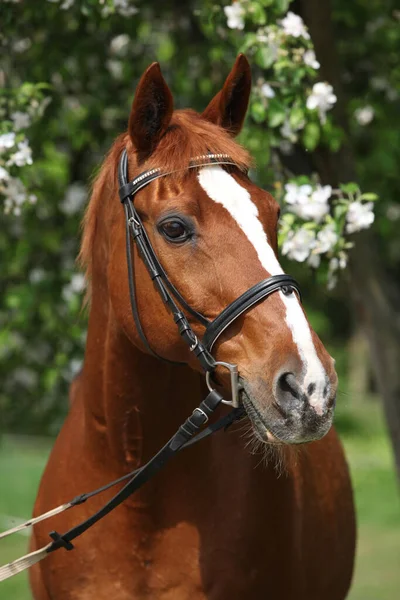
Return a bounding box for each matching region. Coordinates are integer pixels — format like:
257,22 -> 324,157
198,165 -> 327,411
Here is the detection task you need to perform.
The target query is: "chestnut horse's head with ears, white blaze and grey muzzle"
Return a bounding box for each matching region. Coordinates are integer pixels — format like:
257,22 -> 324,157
90,55 -> 337,443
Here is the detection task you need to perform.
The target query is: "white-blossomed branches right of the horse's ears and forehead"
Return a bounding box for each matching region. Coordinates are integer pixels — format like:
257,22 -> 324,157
203,0 -> 377,288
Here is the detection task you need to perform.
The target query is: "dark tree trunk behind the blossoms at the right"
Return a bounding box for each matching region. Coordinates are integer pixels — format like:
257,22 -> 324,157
297,0 -> 400,478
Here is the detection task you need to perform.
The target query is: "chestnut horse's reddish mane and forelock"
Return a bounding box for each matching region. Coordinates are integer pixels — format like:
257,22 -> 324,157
79,110 -> 251,288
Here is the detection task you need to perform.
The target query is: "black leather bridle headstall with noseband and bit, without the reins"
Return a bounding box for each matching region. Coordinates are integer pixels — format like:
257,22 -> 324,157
118,150 -> 301,407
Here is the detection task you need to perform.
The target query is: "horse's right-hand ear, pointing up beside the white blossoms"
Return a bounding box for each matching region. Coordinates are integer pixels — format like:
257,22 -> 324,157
202,54 -> 251,135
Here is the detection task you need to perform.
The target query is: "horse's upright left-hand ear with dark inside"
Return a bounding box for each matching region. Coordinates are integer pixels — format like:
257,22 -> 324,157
128,62 -> 174,161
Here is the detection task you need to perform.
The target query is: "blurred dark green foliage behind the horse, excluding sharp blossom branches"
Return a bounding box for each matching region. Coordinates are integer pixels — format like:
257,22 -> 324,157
0,0 -> 400,433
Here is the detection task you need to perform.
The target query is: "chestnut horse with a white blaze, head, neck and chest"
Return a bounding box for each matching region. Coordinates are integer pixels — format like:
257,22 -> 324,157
31,55 -> 355,600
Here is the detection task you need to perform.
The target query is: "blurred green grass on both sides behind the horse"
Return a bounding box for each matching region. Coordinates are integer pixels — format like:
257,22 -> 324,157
0,402 -> 400,600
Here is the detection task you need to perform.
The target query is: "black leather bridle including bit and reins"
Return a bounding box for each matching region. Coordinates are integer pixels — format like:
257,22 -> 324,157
0,150 -> 301,582
